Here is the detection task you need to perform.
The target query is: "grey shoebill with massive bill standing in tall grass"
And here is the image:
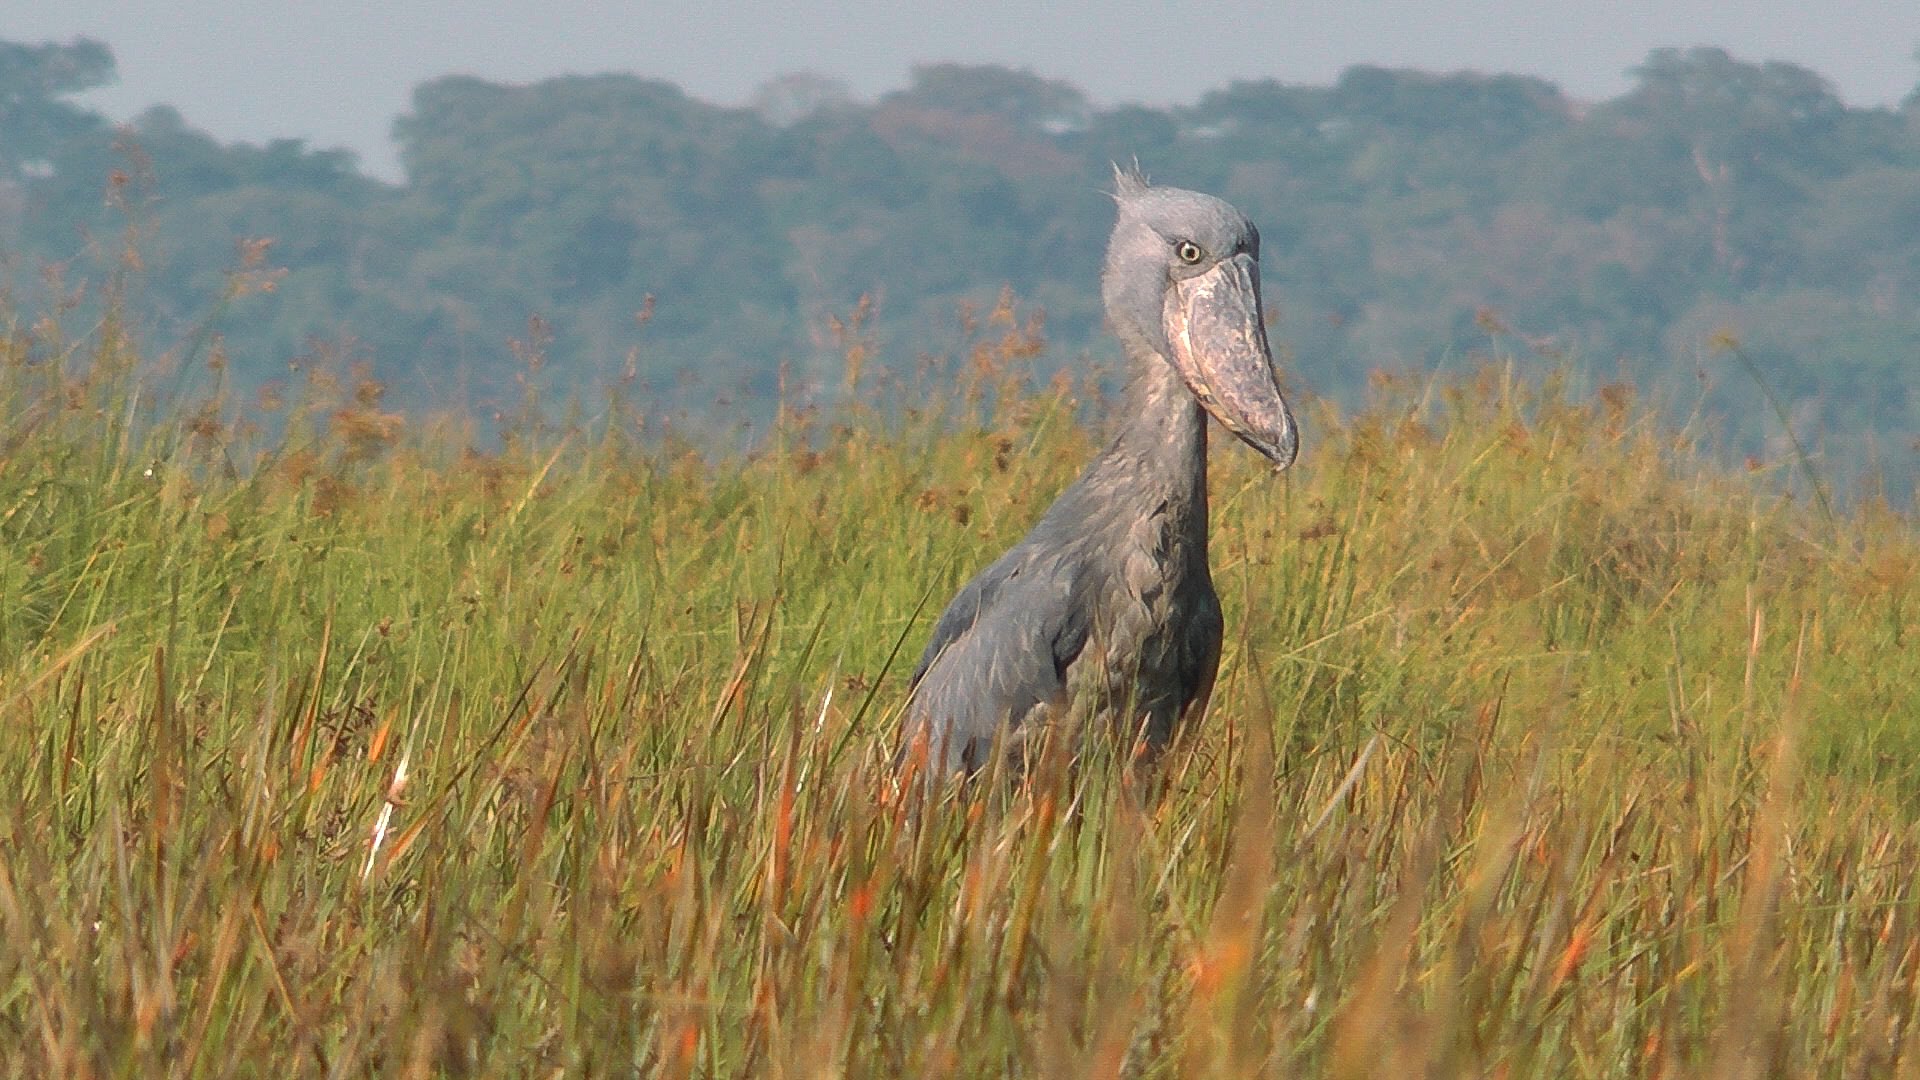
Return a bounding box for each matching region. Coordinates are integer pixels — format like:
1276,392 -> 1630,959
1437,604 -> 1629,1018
902,173 -> 1298,773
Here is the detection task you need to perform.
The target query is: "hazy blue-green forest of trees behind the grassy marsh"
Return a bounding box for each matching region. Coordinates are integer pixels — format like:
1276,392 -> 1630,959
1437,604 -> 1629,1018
11,40 -> 1920,502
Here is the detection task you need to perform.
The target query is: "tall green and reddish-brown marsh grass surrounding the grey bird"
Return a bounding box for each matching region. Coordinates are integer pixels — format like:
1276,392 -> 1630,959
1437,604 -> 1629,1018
0,278 -> 1920,1078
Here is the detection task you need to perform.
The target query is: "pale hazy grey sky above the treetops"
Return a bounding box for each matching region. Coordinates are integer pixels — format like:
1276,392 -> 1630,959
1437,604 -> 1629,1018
11,0 -> 1920,177
